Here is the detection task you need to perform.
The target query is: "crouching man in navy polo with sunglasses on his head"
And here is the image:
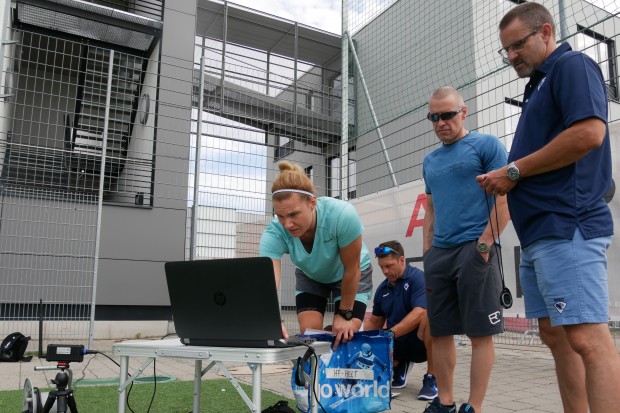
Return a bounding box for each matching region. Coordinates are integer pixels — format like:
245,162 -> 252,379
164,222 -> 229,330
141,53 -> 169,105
364,241 -> 437,400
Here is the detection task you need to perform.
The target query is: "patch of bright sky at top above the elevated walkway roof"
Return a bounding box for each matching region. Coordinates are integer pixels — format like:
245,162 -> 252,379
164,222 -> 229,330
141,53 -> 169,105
234,0 -> 342,34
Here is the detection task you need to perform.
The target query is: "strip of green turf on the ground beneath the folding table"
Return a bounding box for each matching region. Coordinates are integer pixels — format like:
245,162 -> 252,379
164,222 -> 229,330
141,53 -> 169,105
0,379 -> 295,413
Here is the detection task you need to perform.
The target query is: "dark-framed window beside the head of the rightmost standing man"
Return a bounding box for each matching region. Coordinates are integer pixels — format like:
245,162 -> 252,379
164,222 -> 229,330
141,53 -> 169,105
575,26 -> 618,100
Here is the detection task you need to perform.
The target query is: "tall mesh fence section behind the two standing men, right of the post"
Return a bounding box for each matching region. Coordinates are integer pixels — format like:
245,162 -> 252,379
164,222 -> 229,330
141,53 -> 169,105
342,0 -> 620,345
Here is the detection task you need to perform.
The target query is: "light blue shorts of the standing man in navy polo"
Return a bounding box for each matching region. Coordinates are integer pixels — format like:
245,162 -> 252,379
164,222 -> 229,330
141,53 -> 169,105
519,228 -> 611,326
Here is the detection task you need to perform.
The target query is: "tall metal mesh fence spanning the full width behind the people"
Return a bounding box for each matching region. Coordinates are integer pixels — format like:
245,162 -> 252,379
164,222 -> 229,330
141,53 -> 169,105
0,0 -> 620,345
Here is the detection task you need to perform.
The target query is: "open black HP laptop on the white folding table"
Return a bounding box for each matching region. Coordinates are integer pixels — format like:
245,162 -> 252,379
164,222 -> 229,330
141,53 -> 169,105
164,257 -> 296,348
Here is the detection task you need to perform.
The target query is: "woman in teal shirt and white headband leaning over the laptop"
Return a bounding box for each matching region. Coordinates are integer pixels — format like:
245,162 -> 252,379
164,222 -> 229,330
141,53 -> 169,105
260,161 -> 372,346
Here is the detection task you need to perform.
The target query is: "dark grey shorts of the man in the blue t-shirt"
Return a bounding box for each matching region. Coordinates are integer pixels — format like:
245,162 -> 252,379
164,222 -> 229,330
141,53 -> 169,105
424,241 -> 504,337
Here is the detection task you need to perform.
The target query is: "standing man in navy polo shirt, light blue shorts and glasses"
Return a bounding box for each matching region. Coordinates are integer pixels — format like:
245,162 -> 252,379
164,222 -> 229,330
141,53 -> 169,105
477,2 -> 620,413
